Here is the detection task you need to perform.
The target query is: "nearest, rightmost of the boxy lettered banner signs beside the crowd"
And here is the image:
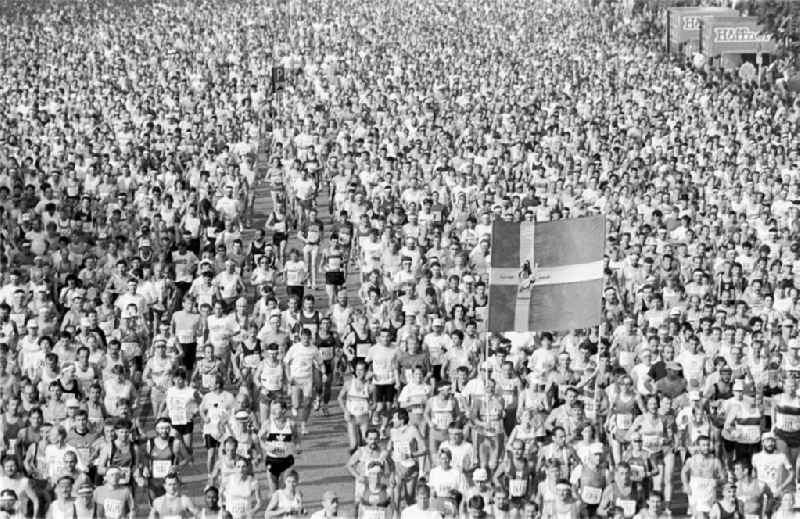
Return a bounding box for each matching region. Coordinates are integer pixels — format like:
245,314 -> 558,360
700,16 -> 777,57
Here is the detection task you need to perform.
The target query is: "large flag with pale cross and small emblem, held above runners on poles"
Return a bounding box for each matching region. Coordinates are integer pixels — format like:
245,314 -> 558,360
487,216 -> 606,332
